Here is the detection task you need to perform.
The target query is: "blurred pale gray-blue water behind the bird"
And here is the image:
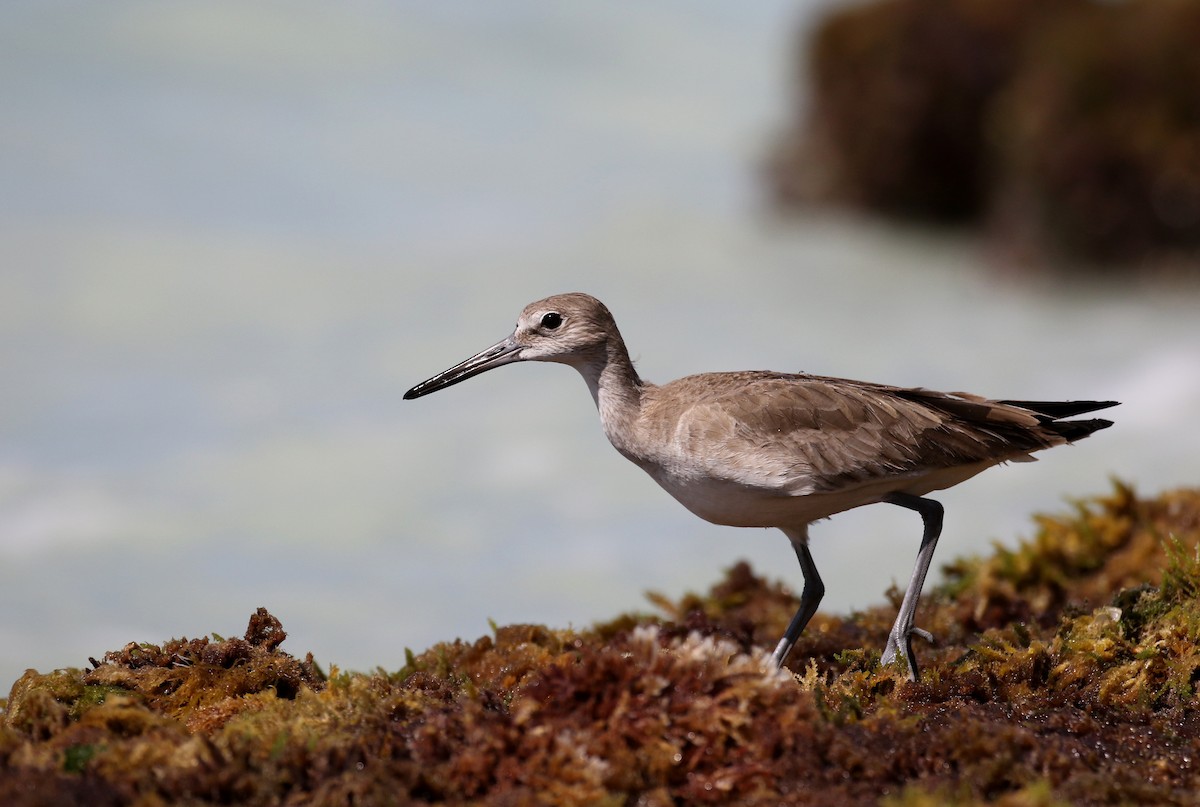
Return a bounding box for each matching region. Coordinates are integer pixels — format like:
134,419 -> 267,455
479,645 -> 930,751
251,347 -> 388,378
0,0 -> 1200,689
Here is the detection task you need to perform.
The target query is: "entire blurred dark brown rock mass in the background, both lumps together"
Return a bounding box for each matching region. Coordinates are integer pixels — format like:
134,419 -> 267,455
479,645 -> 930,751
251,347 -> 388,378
767,0 -> 1200,267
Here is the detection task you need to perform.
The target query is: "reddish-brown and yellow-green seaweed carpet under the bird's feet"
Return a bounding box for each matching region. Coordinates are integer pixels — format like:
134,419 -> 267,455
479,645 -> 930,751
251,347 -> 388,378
0,484 -> 1200,807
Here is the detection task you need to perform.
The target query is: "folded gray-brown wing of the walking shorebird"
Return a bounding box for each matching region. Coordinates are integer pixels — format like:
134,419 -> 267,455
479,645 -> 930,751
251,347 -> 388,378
657,373 -> 1061,494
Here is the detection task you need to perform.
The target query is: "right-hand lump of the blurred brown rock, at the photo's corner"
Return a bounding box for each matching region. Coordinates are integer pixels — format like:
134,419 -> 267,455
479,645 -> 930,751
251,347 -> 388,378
990,0 -> 1200,269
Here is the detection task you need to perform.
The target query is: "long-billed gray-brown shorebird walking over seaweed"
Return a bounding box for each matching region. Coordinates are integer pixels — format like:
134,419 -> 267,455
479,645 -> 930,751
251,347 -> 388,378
404,293 -> 1117,681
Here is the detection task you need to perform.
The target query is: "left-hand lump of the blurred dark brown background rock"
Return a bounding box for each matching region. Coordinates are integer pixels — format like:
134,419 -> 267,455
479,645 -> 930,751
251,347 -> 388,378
769,0 -> 1086,221
